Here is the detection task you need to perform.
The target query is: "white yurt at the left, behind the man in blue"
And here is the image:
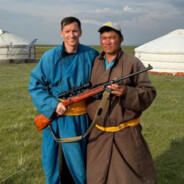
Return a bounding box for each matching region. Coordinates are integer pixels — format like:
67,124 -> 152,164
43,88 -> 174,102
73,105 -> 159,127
0,29 -> 37,64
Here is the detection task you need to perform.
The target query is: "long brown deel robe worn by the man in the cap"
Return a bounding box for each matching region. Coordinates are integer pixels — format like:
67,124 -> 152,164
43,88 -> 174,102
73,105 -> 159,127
87,51 -> 156,184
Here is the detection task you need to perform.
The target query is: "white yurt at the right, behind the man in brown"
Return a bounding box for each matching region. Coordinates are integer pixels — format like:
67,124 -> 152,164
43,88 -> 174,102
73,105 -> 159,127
135,29 -> 184,75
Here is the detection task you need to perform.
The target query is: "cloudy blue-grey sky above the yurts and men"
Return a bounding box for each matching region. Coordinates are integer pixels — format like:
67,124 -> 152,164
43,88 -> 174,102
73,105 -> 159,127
0,0 -> 184,46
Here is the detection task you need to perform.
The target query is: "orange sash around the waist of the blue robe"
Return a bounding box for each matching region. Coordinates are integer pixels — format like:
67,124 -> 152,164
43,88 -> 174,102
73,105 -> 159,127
60,100 -> 87,116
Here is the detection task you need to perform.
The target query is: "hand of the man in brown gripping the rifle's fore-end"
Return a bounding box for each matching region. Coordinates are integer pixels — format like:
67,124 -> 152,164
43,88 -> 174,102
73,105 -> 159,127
108,84 -> 126,97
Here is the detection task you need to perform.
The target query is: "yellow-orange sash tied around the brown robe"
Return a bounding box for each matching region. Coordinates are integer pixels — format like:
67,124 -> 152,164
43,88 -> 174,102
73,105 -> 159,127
95,118 -> 140,132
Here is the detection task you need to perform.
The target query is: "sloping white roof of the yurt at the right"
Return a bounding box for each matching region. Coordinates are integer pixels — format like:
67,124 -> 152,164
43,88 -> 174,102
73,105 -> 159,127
135,29 -> 184,54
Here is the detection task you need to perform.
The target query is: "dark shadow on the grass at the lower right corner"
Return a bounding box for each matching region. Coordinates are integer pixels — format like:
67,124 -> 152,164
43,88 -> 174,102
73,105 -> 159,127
154,138 -> 184,184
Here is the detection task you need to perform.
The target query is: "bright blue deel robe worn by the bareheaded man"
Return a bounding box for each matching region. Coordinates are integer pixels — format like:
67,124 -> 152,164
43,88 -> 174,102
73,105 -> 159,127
29,44 -> 98,184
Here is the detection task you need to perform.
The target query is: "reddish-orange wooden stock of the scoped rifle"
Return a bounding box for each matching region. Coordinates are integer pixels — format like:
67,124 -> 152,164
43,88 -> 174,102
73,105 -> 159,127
34,85 -> 105,130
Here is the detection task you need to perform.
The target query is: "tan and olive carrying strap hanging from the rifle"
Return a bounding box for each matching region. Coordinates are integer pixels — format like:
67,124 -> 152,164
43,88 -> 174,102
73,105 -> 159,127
48,87 -> 111,143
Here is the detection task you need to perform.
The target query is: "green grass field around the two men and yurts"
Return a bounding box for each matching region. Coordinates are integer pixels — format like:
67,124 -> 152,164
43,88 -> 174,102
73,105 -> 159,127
0,47 -> 184,184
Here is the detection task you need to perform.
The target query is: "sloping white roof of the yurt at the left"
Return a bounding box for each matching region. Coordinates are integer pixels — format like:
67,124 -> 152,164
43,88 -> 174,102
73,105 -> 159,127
0,29 -> 29,47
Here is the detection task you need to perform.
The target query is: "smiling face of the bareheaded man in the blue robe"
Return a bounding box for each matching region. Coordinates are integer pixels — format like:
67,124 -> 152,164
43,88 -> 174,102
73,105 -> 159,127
61,22 -> 82,47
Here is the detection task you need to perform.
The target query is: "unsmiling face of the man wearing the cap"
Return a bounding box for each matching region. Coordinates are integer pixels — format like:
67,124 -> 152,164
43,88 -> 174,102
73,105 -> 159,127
100,30 -> 123,55
